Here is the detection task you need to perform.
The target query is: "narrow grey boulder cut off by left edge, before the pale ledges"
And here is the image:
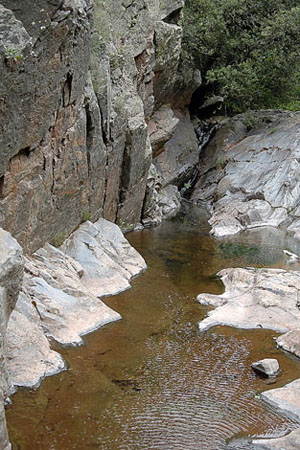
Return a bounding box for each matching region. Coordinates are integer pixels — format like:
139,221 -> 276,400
0,229 -> 23,450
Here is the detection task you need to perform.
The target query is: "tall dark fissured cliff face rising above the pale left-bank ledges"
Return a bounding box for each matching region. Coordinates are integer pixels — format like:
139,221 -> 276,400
0,0 -> 198,253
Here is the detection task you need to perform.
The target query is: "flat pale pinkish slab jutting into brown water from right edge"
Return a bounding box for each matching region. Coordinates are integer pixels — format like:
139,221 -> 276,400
197,268 -> 300,332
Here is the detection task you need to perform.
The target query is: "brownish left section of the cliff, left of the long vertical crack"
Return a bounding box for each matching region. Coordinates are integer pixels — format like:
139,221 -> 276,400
0,0 -> 95,251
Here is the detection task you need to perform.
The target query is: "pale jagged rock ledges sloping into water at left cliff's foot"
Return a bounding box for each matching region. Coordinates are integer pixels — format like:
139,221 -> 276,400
7,219 -> 146,386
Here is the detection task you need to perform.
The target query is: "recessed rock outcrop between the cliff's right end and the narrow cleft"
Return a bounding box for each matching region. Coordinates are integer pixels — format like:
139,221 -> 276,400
142,108 -> 199,226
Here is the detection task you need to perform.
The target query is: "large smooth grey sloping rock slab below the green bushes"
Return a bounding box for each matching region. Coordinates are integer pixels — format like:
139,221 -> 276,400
192,111 -> 300,236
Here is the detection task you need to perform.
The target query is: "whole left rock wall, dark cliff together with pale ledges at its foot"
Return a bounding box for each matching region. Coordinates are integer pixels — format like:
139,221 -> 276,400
0,0 -> 201,444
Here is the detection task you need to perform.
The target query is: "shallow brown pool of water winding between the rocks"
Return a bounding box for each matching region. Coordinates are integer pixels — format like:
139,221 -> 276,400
7,215 -> 300,450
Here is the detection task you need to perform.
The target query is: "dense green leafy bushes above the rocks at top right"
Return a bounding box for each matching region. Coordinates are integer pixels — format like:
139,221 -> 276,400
183,0 -> 300,112
